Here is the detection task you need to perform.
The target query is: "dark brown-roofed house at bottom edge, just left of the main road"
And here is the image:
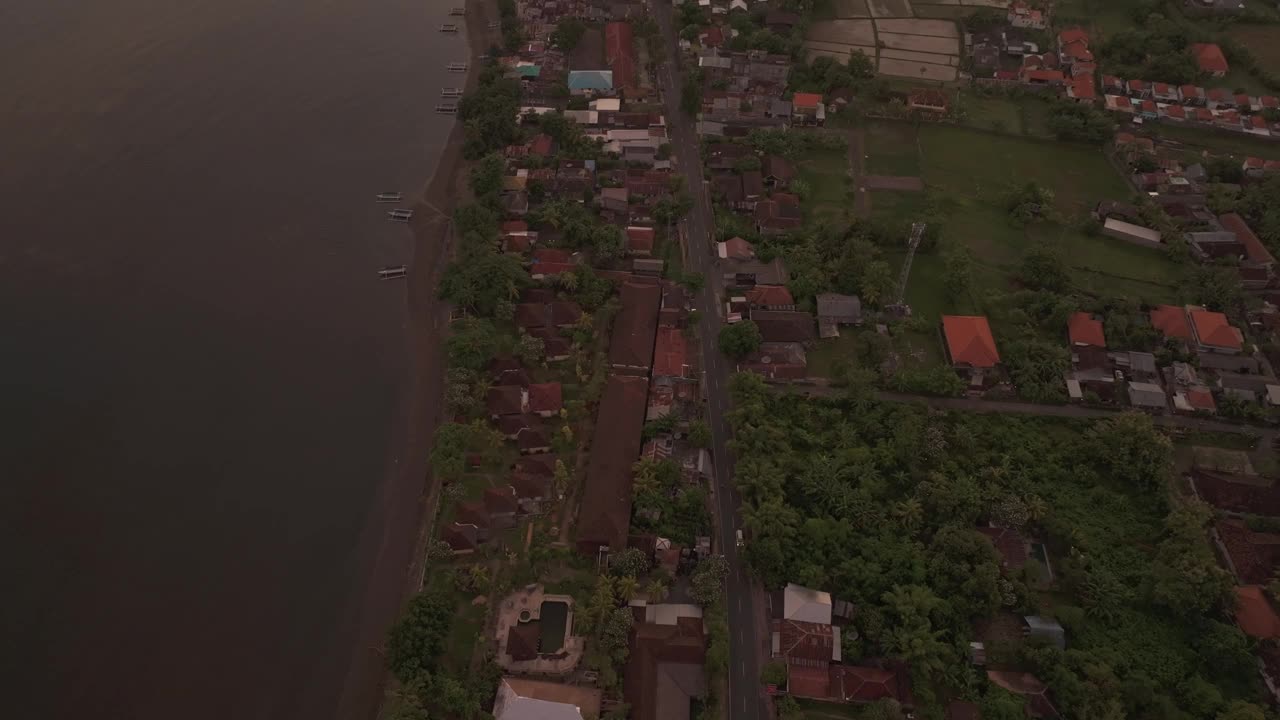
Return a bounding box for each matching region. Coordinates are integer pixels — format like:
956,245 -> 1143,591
622,609 -> 707,720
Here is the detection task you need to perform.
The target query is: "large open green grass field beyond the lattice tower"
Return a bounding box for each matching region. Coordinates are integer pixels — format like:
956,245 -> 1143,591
867,123 -> 1181,311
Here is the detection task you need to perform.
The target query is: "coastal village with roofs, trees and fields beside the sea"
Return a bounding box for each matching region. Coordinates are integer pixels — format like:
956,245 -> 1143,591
385,0 -> 1280,720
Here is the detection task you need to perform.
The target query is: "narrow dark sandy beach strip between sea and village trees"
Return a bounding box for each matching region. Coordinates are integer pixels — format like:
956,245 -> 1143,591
334,0 -> 498,720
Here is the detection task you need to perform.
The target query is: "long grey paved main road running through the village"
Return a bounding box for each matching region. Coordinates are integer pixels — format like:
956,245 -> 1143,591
650,0 -> 769,720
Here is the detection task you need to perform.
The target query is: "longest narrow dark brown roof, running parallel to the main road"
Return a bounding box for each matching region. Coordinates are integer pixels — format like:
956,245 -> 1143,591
577,371 -> 657,556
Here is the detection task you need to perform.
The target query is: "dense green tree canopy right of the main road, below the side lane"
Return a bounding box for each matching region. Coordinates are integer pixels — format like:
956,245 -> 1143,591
730,374 -> 1260,720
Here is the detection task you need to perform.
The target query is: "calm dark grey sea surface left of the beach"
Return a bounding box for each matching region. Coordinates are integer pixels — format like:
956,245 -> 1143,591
0,0 -> 466,720
